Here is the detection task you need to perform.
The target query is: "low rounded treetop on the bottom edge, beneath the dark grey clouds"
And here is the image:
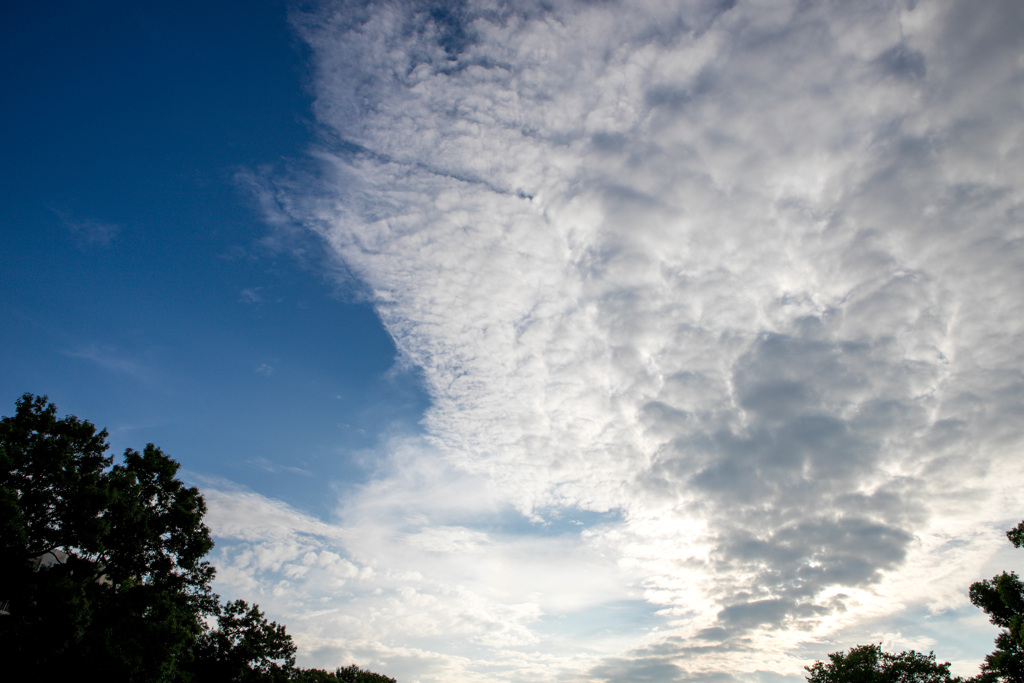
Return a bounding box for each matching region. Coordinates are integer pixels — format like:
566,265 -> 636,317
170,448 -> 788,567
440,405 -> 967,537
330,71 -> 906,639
804,645 -> 963,683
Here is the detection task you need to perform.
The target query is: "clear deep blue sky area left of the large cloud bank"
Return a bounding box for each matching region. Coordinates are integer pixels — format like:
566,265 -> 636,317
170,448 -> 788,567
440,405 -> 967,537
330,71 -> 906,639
0,2 -> 424,505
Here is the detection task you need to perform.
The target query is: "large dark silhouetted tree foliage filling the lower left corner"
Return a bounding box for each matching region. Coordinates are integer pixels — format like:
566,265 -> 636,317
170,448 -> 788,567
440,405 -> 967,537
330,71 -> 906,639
0,394 -> 394,683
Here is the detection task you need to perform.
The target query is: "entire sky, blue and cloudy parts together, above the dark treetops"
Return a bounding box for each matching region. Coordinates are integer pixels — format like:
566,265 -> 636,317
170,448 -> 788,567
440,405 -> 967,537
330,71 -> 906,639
0,0 -> 1024,683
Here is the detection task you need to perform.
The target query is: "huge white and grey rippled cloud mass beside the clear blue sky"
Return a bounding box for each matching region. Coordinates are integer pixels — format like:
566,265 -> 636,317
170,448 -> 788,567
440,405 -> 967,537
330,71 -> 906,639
203,0 -> 1024,681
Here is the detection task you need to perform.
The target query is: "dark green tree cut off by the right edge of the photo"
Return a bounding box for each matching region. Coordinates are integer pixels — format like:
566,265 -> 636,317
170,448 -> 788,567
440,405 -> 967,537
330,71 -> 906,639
970,521 -> 1024,683
